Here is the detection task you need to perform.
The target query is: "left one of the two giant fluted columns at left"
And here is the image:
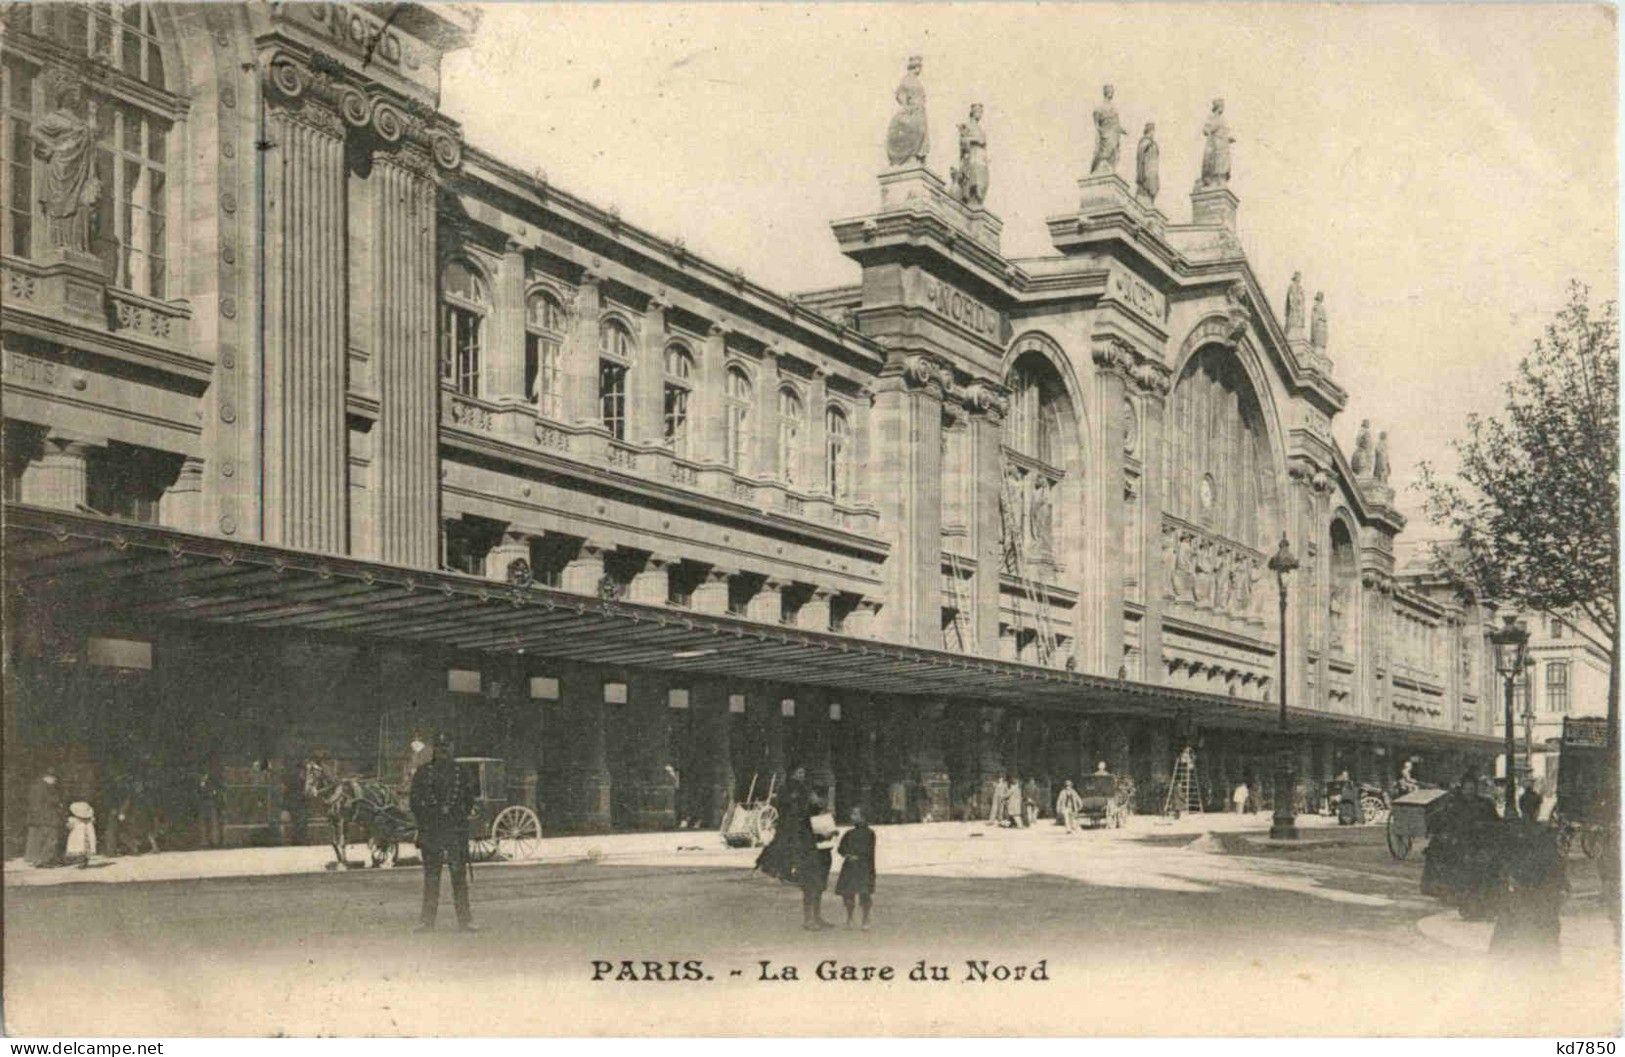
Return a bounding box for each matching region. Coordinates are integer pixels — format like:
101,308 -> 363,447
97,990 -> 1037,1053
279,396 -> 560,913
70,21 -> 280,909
262,98 -> 347,566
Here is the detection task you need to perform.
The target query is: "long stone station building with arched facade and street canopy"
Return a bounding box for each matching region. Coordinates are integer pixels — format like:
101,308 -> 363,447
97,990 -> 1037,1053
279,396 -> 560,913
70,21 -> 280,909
0,3 -> 1495,841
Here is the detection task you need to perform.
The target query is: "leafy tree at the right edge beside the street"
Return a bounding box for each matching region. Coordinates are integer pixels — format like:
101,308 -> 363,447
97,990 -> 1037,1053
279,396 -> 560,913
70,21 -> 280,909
1419,283 -> 1620,930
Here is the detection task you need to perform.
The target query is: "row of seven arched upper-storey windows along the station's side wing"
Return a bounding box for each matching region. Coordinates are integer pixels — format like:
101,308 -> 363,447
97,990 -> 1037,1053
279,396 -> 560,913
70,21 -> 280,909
440,260 -> 852,499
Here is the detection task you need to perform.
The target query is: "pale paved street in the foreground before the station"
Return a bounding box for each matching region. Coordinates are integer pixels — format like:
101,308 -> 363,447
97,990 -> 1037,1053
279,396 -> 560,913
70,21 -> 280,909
5,816 -> 1619,1036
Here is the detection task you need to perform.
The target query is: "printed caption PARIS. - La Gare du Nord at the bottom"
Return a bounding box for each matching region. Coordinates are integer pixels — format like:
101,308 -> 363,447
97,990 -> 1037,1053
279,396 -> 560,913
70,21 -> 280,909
592,958 -> 1050,984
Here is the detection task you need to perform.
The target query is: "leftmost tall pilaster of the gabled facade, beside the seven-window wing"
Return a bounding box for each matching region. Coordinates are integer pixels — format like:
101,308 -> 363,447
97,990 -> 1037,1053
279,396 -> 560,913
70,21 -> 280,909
869,356 -> 943,647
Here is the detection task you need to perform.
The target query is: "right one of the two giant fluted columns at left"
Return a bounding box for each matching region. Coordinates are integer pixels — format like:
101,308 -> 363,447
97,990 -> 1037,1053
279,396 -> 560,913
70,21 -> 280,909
372,146 -> 440,568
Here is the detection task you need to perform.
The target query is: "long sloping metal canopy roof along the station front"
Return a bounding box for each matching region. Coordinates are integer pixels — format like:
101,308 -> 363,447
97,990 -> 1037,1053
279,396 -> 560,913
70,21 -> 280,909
3,502 -> 1497,750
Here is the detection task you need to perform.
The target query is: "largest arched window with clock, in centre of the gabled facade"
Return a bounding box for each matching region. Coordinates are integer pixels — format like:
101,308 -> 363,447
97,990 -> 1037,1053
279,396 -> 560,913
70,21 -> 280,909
1164,346 -> 1281,551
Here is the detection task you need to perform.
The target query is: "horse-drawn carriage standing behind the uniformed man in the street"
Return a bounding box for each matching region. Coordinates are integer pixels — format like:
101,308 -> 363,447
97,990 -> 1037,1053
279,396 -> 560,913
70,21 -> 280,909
306,756 -> 541,867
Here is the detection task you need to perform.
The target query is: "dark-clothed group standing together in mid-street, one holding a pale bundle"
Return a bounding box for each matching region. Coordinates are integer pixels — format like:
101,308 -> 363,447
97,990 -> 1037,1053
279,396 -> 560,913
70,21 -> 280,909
756,766 -> 876,932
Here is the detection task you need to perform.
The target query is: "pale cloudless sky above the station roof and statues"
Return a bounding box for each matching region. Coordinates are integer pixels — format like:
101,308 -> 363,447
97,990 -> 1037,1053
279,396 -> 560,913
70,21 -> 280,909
442,3 -> 1619,526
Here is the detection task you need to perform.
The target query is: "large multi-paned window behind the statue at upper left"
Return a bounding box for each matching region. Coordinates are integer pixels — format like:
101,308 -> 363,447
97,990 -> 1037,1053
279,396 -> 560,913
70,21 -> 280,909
0,3 -> 171,298
